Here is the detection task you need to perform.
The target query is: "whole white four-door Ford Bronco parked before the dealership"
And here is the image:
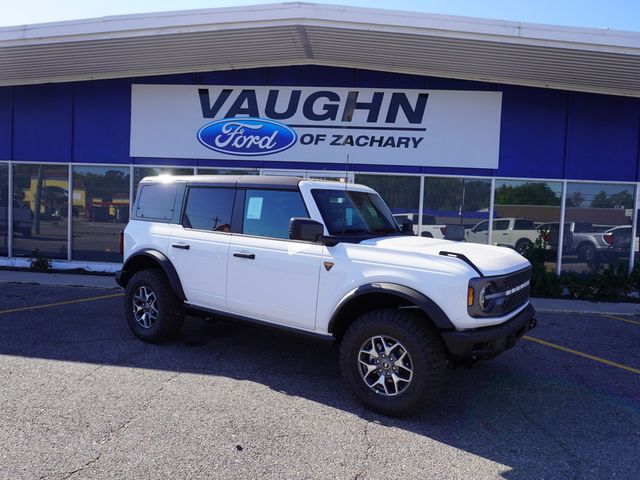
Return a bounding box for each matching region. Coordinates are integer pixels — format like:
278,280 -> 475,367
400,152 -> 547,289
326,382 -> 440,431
116,175 -> 535,416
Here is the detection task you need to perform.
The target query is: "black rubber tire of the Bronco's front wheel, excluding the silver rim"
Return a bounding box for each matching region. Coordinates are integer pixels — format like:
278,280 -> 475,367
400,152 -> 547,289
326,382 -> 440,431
340,309 -> 447,417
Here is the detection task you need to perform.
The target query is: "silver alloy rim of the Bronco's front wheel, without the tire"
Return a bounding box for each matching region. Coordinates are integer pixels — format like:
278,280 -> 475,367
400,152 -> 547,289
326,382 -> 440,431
358,335 -> 413,397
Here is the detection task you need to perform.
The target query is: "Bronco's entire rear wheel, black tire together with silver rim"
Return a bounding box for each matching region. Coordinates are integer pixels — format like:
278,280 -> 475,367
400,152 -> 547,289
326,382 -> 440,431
125,269 -> 184,343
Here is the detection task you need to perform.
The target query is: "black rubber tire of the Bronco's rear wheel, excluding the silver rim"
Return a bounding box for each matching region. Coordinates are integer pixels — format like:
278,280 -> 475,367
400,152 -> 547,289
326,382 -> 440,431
124,269 -> 184,343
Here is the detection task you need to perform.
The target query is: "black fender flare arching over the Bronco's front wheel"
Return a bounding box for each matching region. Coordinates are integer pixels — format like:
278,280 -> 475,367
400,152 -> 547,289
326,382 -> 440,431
328,282 -> 455,333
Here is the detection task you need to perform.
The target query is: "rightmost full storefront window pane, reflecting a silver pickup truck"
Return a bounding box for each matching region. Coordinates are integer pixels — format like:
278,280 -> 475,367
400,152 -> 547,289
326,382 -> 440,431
562,183 -> 635,272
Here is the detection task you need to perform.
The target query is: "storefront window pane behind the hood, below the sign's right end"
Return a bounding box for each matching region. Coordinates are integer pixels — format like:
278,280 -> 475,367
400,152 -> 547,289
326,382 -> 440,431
420,177 -> 491,243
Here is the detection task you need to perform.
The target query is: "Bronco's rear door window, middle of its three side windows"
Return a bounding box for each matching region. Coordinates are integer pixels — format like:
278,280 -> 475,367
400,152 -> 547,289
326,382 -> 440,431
182,187 -> 236,232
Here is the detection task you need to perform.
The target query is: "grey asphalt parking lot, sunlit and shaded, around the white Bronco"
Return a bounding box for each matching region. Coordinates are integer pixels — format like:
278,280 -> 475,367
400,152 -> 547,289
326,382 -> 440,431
0,284 -> 640,480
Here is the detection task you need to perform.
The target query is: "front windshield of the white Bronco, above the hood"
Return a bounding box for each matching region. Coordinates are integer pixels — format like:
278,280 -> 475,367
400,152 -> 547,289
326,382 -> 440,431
311,190 -> 399,235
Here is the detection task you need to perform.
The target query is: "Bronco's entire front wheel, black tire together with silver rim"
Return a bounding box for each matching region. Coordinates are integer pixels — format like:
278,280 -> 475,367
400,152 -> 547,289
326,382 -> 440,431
340,309 -> 446,417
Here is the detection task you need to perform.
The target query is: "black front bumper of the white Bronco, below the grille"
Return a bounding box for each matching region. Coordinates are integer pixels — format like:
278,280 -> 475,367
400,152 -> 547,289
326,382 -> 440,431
441,304 -> 536,360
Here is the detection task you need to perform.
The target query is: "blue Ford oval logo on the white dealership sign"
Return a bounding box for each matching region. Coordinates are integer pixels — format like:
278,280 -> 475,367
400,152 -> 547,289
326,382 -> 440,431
198,117 -> 298,155
